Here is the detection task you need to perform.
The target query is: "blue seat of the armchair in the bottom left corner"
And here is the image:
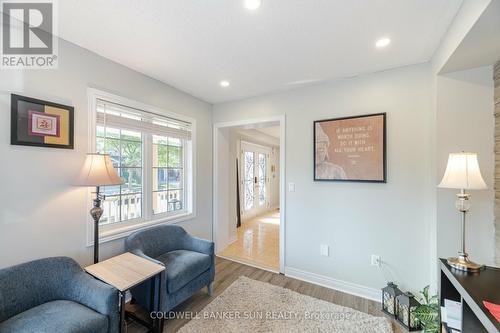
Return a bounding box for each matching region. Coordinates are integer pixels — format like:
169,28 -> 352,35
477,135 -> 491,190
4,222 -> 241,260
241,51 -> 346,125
0,301 -> 108,333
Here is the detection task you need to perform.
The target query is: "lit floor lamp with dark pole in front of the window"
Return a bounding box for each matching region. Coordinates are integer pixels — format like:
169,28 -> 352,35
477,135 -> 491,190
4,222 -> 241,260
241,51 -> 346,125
76,153 -> 123,264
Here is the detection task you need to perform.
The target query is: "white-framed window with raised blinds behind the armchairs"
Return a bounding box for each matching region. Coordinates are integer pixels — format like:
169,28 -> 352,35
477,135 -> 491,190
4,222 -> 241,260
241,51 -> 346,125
92,89 -> 193,234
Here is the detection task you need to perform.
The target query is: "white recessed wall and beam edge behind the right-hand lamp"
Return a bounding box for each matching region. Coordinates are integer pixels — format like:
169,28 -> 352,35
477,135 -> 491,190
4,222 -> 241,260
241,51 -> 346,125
429,0 -> 494,286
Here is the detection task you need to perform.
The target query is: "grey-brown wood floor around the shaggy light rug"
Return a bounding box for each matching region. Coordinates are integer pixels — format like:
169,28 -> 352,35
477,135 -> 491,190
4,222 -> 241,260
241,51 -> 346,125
128,258 -> 405,333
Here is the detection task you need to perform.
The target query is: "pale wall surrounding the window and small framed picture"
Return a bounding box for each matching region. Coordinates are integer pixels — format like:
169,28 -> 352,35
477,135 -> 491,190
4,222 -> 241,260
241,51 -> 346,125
0,40 -> 212,267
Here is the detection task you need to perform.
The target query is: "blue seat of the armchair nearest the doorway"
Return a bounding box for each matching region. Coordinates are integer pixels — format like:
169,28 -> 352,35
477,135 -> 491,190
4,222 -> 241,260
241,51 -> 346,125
157,250 -> 212,293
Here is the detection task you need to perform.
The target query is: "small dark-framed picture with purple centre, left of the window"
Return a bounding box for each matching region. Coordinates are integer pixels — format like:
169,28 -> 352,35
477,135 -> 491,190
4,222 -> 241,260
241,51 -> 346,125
11,94 -> 74,149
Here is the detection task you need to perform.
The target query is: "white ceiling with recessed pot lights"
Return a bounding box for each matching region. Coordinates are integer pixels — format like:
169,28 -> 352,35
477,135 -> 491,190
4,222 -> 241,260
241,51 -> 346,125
58,0 -> 462,103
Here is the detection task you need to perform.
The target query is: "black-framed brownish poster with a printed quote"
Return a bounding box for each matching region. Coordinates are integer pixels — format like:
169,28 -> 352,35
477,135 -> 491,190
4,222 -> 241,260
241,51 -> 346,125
314,113 -> 387,183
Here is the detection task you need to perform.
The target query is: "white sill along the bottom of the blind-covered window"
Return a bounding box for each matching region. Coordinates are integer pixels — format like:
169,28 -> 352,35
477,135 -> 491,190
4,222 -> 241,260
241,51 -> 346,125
87,212 -> 196,247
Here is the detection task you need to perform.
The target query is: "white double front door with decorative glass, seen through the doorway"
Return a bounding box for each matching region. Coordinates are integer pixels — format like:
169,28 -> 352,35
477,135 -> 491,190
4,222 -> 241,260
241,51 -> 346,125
241,142 -> 270,220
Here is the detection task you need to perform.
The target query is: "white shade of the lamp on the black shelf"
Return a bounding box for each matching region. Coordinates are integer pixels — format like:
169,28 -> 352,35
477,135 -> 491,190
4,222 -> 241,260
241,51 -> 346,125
439,153 -> 488,190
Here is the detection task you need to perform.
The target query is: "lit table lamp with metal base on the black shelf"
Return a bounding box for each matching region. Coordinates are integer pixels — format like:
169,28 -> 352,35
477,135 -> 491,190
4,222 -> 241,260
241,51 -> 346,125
439,152 -> 487,272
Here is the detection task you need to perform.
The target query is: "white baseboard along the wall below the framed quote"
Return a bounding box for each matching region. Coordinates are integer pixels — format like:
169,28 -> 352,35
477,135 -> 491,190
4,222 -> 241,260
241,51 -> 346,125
285,267 -> 382,302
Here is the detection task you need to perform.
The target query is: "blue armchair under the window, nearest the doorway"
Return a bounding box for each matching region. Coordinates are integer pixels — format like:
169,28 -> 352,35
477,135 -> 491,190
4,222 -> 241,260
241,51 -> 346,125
125,225 -> 215,312
